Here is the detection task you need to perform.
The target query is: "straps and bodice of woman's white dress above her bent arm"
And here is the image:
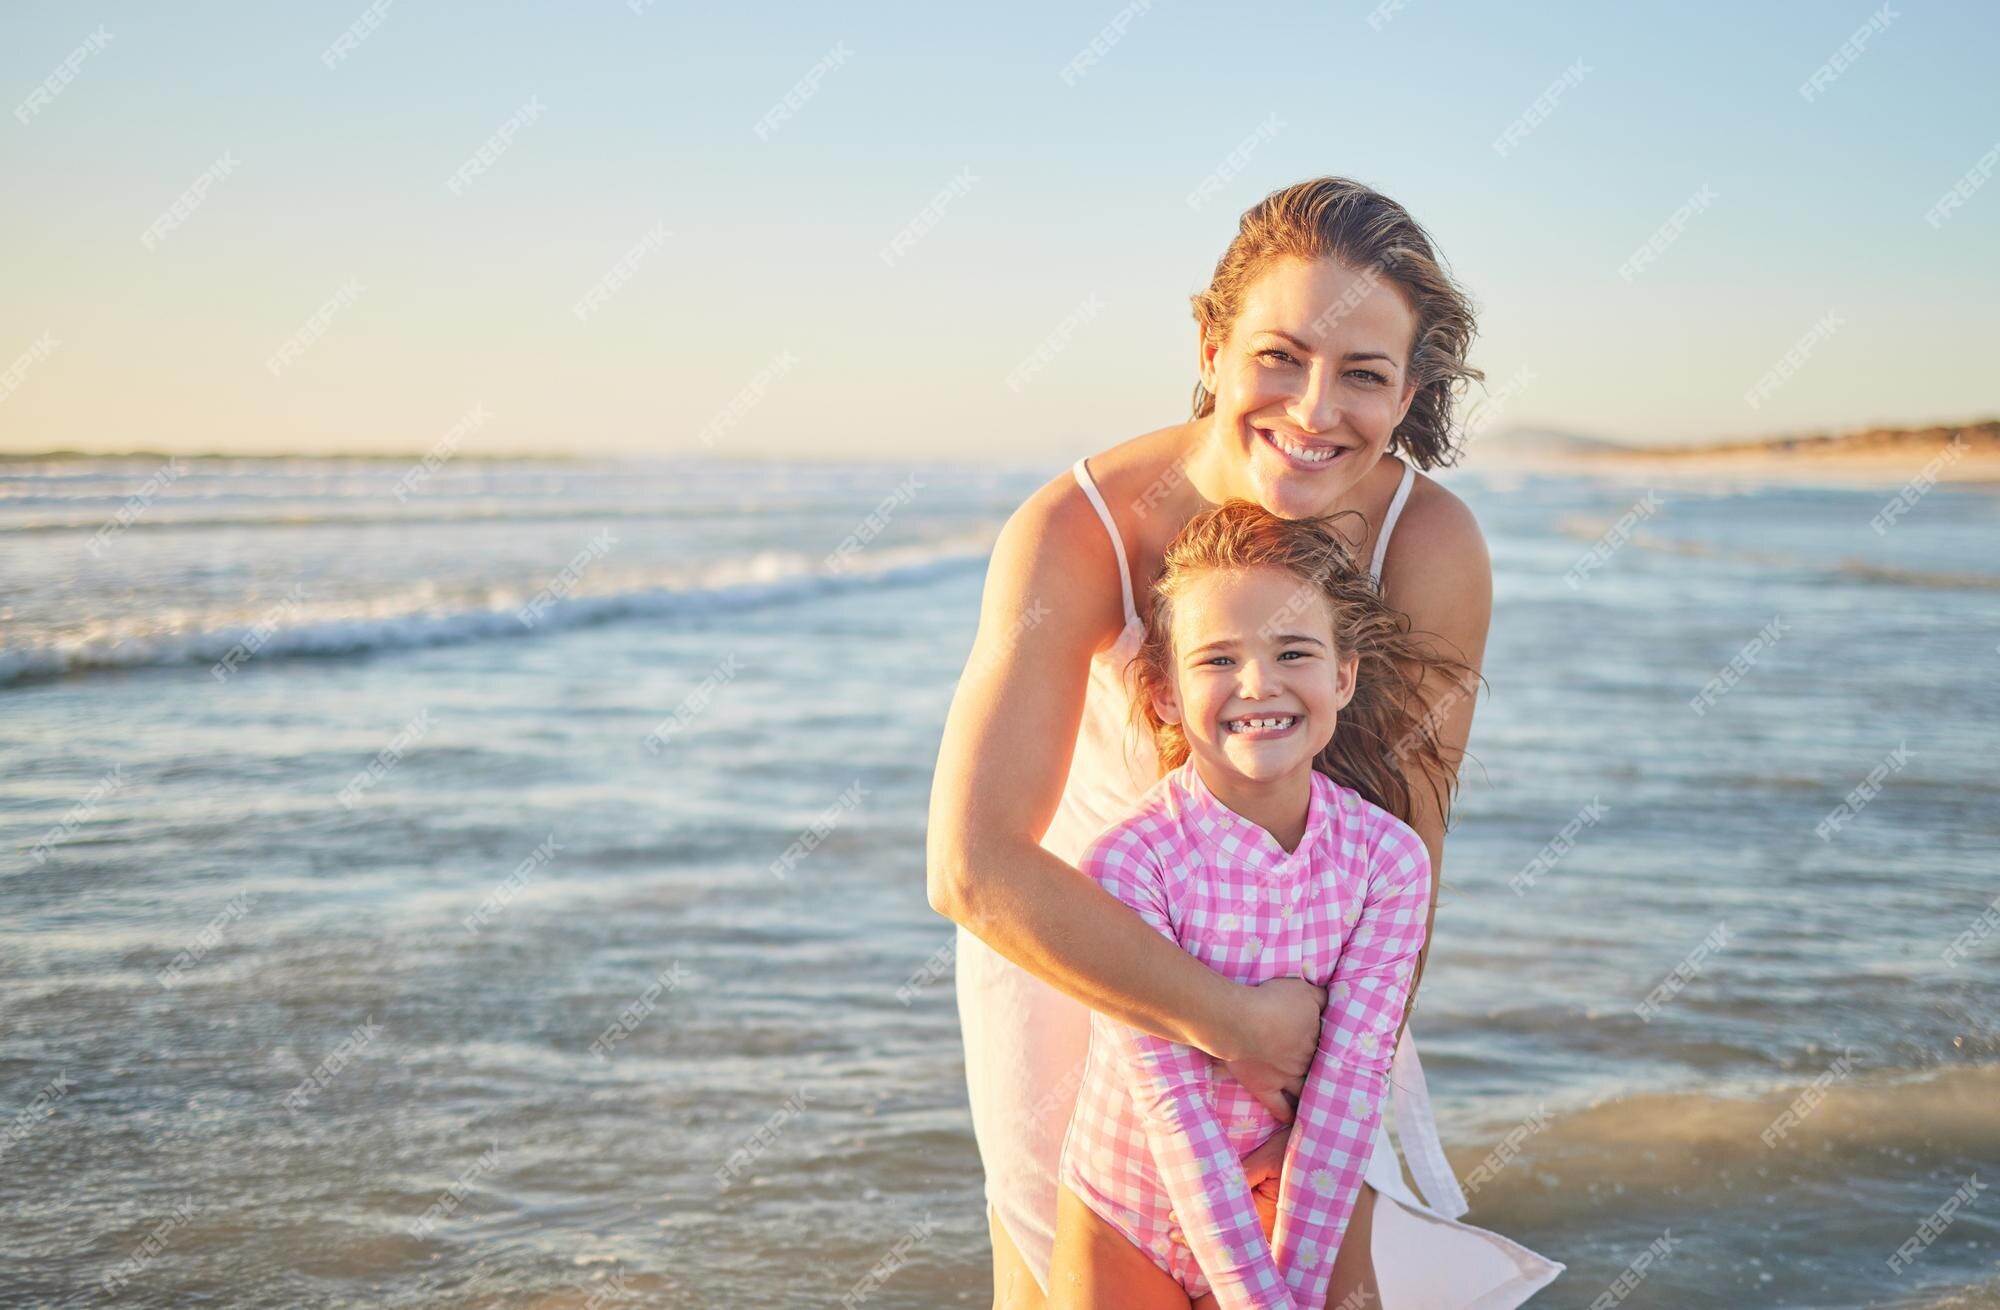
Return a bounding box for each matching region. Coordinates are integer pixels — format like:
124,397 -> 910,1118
1042,460 -> 1416,864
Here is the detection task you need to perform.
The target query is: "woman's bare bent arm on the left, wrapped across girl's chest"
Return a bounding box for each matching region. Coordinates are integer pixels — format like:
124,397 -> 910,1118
926,482 -> 1320,1088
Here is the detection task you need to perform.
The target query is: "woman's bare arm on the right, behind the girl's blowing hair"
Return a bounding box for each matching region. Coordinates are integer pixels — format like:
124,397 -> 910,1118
1382,482 -> 1494,1052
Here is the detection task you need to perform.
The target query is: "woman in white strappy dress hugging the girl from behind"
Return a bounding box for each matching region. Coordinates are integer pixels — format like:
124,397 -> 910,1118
928,178 -> 1562,1310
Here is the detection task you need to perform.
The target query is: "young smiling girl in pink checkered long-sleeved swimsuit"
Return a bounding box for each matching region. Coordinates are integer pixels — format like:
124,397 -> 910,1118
1050,500 -> 1462,1310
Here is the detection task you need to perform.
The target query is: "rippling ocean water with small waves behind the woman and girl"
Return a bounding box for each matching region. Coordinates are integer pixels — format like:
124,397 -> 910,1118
0,460 -> 2000,1308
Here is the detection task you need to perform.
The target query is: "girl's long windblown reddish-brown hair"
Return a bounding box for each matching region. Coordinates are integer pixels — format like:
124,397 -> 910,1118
1126,500 -> 1476,824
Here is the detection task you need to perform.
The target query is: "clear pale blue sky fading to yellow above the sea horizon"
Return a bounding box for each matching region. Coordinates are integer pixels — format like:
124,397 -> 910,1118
0,0 -> 2000,462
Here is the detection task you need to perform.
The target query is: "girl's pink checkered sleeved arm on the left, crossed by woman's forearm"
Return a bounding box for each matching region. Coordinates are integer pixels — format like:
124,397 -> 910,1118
1082,828 -> 1296,1310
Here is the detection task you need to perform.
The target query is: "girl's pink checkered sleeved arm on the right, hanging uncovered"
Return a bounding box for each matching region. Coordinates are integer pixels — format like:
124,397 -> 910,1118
1272,822 -> 1430,1306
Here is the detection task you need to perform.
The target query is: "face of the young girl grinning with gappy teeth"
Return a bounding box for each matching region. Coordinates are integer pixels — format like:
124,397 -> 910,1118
1154,568 -> 1356,782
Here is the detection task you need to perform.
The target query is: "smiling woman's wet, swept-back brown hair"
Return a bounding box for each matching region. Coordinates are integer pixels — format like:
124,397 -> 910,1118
1190,178 -> 1486,468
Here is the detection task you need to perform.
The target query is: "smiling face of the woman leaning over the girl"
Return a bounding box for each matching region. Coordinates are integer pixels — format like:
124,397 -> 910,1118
1200,258 -> 1416,518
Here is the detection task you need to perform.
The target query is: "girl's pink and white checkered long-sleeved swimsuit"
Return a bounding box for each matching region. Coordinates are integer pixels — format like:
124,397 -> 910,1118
1060,758 -> 1430,1310
